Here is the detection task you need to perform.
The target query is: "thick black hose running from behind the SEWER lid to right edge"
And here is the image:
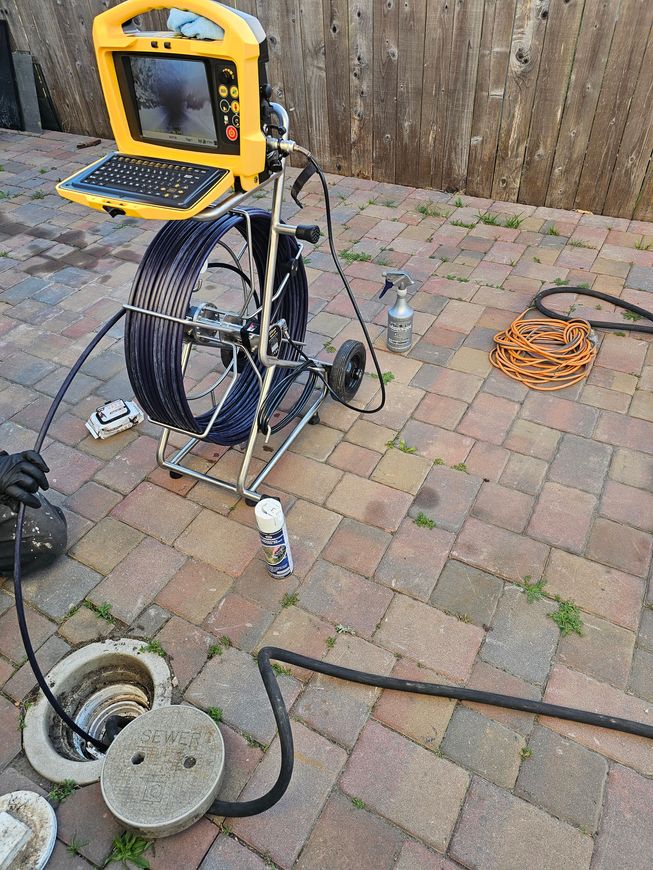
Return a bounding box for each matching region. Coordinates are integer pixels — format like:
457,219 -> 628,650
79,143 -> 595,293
209,646 -> 653,818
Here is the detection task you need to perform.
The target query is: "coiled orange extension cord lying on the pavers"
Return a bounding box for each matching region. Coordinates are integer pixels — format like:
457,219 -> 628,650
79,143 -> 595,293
490,308 -> 596,390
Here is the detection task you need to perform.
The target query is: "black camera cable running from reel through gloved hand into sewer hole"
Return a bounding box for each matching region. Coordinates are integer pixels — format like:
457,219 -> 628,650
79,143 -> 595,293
14,308 -> 125,750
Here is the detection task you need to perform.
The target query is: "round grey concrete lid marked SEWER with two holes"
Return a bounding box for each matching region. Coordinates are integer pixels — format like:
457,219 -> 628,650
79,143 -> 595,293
100,705 -> 224,837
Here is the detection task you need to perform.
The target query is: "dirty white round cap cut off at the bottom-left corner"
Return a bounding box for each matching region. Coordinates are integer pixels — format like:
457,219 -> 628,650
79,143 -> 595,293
0,791 -> 57,870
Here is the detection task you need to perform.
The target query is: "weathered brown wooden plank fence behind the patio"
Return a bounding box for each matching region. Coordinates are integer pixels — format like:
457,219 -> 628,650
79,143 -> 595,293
0,0 -> 653,220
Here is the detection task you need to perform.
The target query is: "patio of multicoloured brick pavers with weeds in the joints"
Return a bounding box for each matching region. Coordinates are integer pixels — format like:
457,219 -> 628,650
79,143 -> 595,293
0,132 -> 653,870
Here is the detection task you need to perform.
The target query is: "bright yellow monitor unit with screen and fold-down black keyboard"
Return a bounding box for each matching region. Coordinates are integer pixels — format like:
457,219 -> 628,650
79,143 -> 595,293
57,0 -> 267,220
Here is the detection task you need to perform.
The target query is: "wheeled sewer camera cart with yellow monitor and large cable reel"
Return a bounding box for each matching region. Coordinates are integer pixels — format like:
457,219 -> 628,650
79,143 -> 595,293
57,0 -> 366,505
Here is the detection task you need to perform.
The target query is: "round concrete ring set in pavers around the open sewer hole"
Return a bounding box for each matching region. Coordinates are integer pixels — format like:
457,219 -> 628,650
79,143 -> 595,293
23,638 -> 172,785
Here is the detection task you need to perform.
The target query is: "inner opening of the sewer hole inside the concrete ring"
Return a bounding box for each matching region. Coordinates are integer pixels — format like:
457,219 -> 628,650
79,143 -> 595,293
49,653 -> 154,764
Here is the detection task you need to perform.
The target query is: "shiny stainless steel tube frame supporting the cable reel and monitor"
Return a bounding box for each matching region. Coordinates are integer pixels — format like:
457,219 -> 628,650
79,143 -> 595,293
137,103 -> 329,502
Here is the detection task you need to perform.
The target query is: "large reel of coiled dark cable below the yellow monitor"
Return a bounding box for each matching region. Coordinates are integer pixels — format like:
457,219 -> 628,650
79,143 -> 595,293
125,193 -> 366,502
